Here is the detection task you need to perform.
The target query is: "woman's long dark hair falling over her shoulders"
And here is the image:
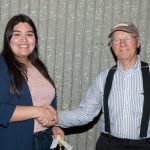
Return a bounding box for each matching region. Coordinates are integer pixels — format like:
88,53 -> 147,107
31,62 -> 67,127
1,14 -> 55,94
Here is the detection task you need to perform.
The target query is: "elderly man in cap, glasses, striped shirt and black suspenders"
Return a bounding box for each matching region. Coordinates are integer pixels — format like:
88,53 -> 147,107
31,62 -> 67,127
59,23 -> 150,150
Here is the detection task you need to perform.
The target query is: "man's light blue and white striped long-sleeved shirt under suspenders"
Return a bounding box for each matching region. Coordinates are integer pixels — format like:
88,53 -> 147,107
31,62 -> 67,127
59,58 -> 150,139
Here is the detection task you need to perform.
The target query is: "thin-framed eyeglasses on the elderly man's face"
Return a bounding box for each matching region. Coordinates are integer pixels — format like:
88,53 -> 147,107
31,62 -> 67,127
111,36 -> 137,45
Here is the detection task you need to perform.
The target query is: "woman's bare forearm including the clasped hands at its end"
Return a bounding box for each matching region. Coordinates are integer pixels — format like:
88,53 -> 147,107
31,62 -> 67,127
9,106 -> 57,127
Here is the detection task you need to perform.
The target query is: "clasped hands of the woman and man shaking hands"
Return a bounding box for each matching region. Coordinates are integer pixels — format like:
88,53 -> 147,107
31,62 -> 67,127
35,105 -> 58,128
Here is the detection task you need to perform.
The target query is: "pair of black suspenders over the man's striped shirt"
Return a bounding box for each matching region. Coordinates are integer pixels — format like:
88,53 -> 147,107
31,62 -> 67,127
103,61 -> 150,137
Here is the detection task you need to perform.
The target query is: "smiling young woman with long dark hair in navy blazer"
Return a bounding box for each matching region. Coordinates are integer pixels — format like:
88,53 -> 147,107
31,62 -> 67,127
0,14 -> 64,150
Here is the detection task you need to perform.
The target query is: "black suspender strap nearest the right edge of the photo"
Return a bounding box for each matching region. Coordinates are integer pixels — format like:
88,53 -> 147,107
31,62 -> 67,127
140,62 -> 150,137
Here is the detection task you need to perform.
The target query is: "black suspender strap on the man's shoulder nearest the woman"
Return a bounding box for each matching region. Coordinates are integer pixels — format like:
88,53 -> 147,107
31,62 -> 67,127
103,65 -> 117,133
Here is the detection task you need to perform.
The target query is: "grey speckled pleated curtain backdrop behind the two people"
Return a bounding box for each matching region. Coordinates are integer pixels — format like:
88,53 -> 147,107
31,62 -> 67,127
0,0 -> 150,150
